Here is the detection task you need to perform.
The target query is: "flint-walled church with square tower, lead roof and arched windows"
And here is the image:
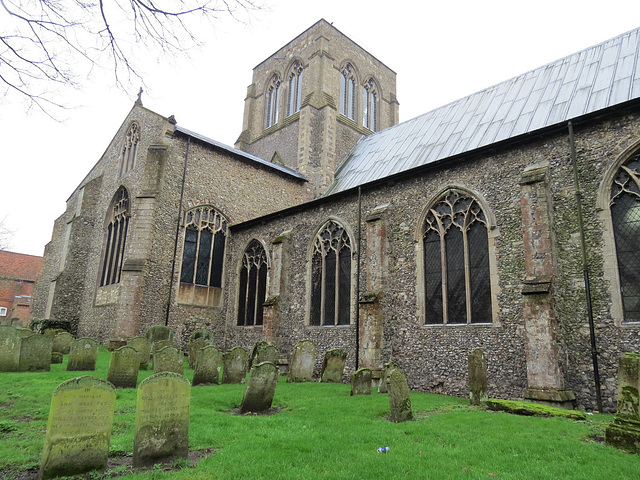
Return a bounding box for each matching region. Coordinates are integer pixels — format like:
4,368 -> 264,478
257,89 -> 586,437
31,20 -> 640,410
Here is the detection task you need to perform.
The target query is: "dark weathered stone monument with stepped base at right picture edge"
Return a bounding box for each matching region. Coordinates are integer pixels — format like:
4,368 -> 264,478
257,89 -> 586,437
605,353 -> 640,453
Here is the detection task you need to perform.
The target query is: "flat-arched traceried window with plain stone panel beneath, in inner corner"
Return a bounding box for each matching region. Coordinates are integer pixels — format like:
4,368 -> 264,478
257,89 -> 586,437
180,206 -> 227,288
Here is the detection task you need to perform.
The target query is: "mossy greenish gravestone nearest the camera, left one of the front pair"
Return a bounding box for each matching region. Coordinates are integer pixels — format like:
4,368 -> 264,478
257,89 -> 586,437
40,376 -> 116,480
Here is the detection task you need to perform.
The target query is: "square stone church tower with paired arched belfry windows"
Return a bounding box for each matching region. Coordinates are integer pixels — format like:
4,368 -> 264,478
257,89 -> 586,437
235,20 -> 398,199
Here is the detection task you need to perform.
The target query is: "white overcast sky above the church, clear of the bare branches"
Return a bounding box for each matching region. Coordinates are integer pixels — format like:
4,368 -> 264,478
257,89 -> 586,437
0,0 -> 640,255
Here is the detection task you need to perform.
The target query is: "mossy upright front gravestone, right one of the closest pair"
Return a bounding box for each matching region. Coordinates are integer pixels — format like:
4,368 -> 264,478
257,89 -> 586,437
133,370 -> 191,467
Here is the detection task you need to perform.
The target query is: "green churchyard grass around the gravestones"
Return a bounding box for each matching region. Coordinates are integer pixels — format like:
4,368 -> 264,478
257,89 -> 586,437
0,350 -> 640,480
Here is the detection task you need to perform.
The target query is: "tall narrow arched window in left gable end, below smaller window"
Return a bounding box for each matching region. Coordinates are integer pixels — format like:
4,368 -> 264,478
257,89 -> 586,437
100,187 -> 130,287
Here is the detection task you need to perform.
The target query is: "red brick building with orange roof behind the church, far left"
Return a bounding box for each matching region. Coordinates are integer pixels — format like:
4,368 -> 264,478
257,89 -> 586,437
0,250 -> 42,327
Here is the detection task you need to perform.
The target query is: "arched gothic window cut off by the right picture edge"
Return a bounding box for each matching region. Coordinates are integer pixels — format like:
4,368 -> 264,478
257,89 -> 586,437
609,152 -> 640,322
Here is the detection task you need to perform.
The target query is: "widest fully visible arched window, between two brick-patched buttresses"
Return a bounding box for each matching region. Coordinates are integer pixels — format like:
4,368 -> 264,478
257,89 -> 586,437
422,190 -> 491,324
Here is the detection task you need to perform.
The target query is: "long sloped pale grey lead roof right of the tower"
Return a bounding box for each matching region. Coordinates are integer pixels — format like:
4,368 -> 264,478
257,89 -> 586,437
327,28 -> 640,194
